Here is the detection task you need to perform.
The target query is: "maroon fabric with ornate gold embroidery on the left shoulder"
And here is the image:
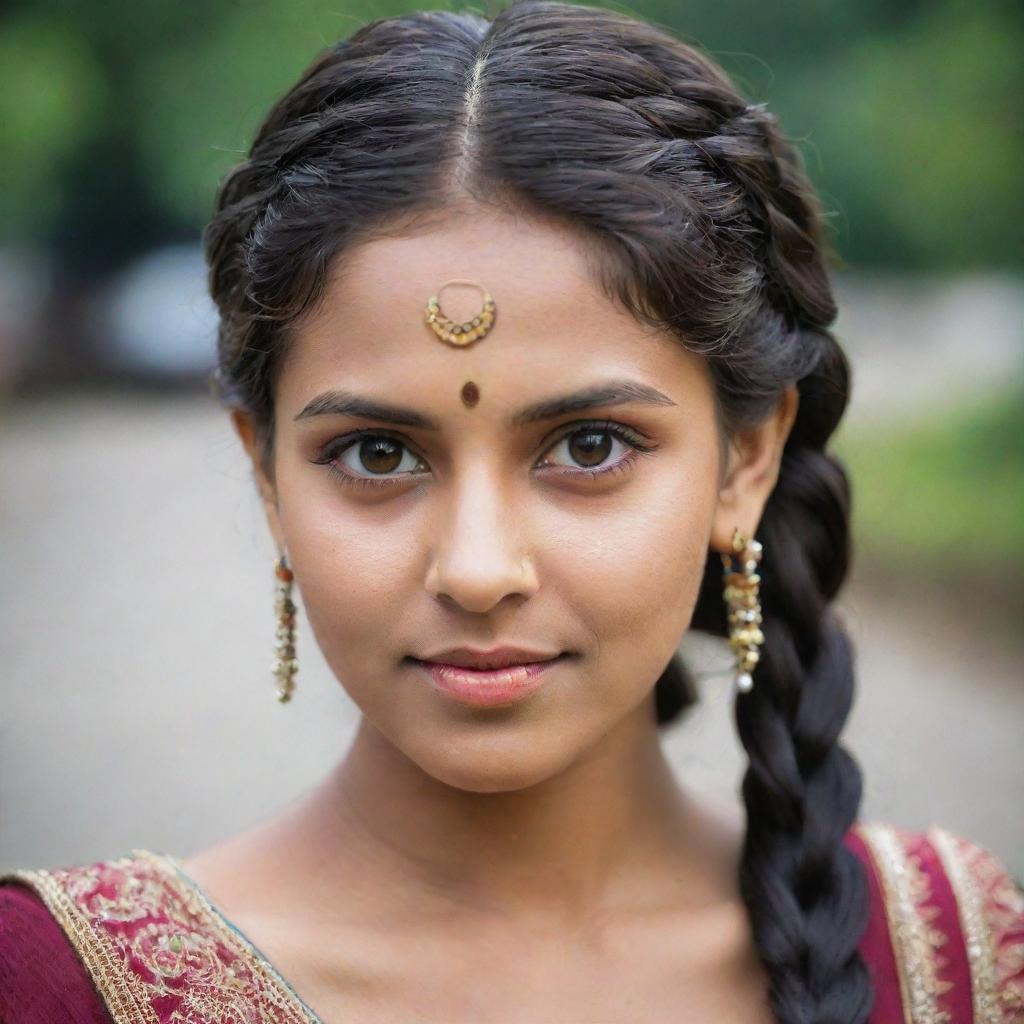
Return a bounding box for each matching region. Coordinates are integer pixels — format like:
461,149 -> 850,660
0,850 -> 310,1024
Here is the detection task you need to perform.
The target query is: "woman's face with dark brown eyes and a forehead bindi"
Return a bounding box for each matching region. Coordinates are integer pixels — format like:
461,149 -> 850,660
237,209 -> 774,792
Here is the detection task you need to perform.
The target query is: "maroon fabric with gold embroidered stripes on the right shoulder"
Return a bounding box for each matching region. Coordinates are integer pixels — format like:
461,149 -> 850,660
847,821 -> 1024,1024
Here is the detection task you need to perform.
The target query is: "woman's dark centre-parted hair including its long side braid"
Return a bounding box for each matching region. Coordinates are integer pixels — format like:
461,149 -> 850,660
204,0 -> 873,1024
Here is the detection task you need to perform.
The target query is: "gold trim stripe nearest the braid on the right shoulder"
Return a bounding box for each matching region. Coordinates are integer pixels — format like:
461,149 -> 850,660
858,822 -> 951,1024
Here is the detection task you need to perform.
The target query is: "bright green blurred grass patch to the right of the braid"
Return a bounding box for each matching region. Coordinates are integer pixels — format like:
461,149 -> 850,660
836,387 -> 1024,577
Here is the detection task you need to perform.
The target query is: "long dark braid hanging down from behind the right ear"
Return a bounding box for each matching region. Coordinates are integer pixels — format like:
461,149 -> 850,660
735,446 -> 871,1024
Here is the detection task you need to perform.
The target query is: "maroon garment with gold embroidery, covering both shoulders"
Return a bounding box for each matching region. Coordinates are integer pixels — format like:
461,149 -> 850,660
0,823 -> 1024,1024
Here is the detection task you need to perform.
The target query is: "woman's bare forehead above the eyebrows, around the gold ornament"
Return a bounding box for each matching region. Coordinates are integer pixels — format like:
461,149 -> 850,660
279,213 -> 699,415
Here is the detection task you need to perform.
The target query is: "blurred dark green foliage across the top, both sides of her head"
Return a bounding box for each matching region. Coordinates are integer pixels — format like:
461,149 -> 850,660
0,0 -> 1024,269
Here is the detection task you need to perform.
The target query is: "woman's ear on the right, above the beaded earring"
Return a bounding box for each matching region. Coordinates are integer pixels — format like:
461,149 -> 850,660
710,384 -> 800,553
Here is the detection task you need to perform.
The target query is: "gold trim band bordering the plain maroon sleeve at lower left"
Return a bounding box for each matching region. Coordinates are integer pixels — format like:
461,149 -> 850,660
0,870 -> 160,1024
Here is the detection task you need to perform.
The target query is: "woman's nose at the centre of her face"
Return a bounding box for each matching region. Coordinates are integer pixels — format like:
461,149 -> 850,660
426,472 -> 539,613
